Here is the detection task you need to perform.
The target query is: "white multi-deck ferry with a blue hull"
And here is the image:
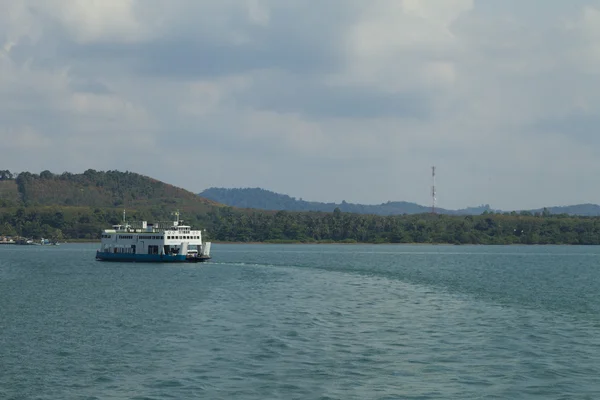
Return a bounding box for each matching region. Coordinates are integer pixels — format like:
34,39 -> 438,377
96,211 -> 211,262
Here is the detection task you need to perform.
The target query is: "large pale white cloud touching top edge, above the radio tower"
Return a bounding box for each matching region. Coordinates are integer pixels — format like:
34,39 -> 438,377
338,0 -> 473,92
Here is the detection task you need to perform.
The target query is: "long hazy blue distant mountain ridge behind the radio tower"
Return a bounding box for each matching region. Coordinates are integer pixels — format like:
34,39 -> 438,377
199,188 -> 491,215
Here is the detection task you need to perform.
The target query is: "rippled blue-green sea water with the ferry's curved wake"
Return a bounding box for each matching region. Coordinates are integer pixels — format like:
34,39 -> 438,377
0,244 -> 600,399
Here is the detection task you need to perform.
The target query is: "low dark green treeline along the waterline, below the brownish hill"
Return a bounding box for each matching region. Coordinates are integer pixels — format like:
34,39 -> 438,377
0,207 -> 600,245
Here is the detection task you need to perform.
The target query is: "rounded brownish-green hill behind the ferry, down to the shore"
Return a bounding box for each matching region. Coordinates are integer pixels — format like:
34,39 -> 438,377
0,169 -> 222,240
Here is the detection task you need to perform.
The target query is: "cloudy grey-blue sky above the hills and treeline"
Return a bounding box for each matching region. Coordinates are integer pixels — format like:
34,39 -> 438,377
0,0 -> 600,210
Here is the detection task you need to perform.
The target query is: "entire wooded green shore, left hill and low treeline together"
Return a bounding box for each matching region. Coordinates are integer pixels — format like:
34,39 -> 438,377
0,170 -> 600,245
